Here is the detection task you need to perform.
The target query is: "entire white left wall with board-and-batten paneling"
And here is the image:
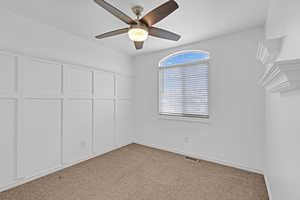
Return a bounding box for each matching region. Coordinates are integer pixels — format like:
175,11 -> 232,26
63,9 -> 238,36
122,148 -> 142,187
0,8 -> 133,191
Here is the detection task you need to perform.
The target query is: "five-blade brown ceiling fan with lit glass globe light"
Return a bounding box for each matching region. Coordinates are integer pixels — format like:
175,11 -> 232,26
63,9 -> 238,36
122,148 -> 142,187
94,0 -> 181,50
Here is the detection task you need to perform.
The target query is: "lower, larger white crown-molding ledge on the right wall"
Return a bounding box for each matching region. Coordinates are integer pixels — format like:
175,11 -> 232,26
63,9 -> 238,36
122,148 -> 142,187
260,59 -> 300,92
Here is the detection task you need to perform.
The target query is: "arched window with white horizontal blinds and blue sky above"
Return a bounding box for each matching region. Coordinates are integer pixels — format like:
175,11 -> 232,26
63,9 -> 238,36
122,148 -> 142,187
159,51 -> 209,118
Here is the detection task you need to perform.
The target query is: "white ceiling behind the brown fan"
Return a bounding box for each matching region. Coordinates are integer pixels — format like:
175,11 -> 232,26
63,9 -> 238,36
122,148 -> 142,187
1,0 -> 267,55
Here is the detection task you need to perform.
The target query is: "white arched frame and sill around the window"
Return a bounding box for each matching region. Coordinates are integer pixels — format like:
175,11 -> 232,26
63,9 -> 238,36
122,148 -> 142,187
157,50 -> 211,123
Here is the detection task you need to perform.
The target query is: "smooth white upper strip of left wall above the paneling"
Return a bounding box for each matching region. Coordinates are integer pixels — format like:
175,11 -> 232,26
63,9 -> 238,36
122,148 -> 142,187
0,7 -> 132,74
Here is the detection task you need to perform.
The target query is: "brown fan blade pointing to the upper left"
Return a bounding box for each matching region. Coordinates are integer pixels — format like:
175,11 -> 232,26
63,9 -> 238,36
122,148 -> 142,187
95,0 -> 136,24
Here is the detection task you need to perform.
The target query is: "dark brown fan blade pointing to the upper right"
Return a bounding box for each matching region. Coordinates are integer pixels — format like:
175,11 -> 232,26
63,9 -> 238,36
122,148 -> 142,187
140,0 -> 179,26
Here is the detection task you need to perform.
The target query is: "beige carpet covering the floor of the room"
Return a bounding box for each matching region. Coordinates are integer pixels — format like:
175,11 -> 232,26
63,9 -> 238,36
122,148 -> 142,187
0,144 -> 268,200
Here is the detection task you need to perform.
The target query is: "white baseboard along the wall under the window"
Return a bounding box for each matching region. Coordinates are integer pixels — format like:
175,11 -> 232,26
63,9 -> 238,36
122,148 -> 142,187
135,142 -> 263,174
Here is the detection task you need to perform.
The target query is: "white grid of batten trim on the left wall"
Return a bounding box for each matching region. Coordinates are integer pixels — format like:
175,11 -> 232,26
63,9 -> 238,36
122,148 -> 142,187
0,48 -> 134,192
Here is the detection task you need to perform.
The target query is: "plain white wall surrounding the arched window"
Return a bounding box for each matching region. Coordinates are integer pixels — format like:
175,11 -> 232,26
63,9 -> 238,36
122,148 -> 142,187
134,28 -> 265,171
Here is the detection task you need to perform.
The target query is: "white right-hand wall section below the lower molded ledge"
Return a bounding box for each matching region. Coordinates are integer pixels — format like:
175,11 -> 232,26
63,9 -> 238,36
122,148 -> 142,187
265,92 -> 300,200
